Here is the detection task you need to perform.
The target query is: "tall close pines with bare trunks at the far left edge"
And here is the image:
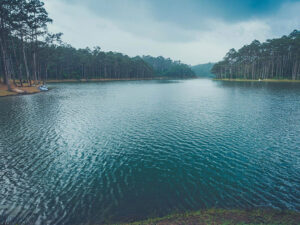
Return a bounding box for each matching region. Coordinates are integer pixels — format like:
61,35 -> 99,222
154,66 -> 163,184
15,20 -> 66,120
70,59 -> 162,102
0,0 -> 52,89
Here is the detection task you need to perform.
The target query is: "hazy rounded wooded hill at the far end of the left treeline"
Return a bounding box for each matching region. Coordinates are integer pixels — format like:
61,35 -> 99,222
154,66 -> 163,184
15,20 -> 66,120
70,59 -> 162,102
143,55 -> 196,78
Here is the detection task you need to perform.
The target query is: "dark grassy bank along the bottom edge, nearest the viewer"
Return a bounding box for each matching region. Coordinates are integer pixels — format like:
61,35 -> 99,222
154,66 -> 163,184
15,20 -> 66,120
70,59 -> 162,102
119,209 -> 300,225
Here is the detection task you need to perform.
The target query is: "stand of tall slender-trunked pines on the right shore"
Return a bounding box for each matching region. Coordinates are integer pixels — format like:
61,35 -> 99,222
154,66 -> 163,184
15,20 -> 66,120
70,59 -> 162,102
212,30 -> 300,80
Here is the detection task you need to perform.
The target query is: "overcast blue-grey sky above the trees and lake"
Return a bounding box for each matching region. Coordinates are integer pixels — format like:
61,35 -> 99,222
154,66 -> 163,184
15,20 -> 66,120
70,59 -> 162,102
45,0 -> 300,65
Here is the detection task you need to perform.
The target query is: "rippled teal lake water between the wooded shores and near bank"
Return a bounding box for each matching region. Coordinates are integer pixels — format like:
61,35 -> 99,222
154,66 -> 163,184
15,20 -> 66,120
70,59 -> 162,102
0,80 -> 300,224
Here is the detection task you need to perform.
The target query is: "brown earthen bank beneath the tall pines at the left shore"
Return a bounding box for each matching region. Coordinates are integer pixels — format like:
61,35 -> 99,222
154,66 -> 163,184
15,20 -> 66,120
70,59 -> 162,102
0,83 -> 40,97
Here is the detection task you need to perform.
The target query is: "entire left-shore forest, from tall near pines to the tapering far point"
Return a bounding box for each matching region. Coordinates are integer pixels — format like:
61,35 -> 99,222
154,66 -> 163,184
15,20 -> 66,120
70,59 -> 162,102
0,0 -> 195,87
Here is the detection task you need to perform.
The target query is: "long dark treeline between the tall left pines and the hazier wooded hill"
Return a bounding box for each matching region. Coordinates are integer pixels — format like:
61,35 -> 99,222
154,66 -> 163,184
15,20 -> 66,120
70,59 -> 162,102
43,45 -> 153,80
